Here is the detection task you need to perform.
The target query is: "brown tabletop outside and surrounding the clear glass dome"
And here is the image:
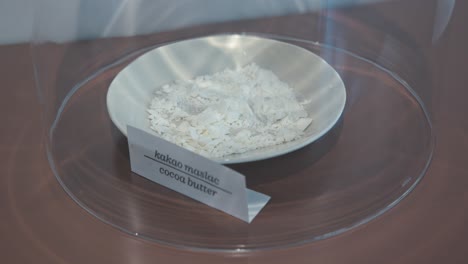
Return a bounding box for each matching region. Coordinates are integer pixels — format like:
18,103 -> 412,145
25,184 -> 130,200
0,1 -> 468,263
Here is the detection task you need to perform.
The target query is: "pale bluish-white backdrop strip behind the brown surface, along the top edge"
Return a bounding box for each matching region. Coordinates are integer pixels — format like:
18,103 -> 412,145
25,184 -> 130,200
0,0 -> 384,44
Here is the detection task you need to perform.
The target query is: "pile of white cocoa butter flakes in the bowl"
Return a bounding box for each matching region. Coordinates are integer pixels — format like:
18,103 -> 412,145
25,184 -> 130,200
148,64 -> 311,158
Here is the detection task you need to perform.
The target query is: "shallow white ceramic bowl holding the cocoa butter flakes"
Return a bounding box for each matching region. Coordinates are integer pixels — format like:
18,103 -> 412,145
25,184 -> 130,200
107,35 -> 346,164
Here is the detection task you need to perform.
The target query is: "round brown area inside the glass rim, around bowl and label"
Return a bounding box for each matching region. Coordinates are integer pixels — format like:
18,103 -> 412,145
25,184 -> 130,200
48,36 -> 433,252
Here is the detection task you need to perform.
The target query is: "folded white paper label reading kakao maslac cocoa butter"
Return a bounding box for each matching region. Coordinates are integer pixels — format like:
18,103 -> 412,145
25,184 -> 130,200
127,126 -> 270,223
